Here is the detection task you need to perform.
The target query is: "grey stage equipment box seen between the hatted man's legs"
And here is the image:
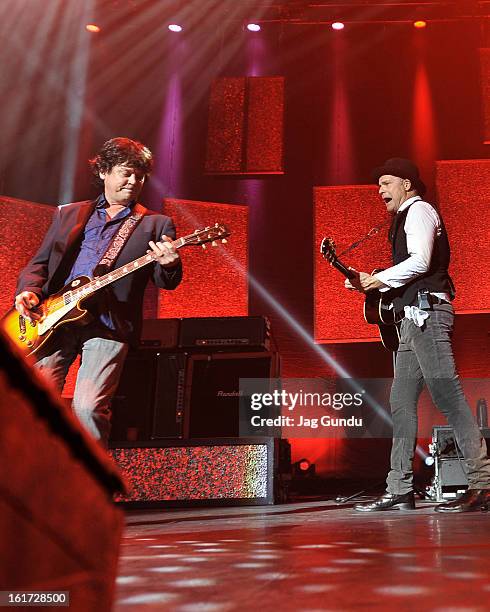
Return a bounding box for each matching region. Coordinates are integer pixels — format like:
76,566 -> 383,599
428,425 -> 490,501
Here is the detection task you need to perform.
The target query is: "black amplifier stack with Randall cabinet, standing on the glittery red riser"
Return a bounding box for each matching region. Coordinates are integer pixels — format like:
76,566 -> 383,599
111,317 -> 280,444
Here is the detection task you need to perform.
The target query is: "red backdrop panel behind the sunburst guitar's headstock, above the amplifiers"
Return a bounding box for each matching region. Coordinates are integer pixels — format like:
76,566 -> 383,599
158,199 -> 248,318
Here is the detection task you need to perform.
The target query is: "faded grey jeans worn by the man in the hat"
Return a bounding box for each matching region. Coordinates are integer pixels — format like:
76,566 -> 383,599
387,304 -> 490,495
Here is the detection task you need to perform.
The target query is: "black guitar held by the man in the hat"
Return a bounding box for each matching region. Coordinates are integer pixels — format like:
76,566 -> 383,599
320,237 -> 403,351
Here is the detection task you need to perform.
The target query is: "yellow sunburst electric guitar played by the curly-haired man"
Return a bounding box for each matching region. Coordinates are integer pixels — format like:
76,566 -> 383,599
0,223 -> 230,355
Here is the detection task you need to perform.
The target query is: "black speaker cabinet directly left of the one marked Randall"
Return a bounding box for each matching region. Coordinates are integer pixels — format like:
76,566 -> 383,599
110,349 -> 187,442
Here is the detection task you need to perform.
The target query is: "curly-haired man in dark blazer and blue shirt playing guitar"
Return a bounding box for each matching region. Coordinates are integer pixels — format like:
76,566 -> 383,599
15,138 -> 182,445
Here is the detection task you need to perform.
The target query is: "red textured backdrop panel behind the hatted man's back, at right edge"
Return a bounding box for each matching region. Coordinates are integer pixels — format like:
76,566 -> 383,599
436,159 -> 490,312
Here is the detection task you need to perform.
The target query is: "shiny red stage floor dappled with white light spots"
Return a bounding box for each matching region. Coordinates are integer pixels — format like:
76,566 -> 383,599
115,501 -> 490,612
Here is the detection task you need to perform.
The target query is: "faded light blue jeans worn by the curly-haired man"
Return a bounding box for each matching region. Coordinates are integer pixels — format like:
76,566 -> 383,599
36,324 -> 128,446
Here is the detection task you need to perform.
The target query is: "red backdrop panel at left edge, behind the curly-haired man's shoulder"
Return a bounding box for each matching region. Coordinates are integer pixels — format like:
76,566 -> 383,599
0,196 -> 55,316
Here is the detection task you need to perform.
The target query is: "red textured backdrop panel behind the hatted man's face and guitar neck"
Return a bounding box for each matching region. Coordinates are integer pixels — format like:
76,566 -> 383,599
313,185 -> 390,343
